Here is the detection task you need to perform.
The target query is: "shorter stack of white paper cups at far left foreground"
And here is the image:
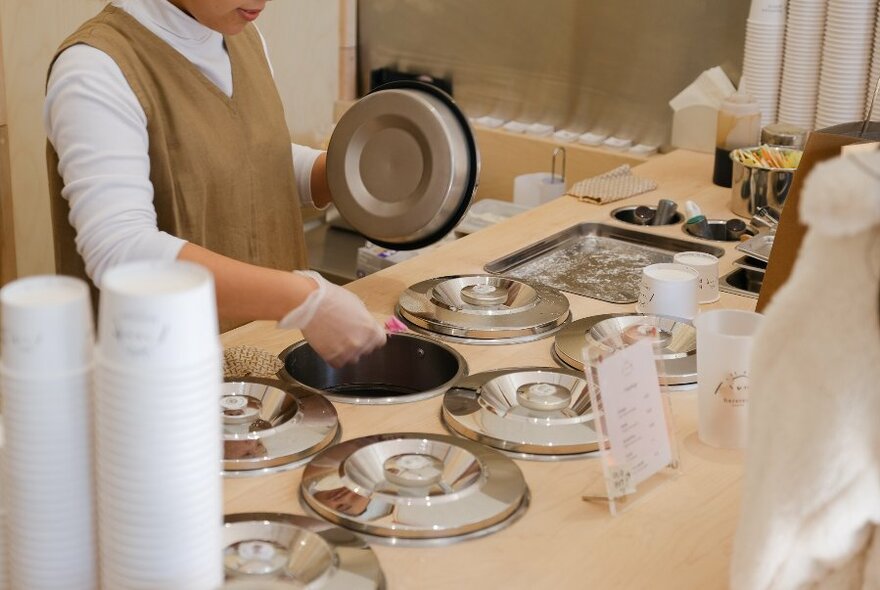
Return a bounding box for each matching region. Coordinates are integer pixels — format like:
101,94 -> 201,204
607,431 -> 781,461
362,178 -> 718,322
0,276 -> 97,590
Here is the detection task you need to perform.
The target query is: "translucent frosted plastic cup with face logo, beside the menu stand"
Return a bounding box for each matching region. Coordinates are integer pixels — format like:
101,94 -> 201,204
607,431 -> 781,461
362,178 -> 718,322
694,309 -> 763,449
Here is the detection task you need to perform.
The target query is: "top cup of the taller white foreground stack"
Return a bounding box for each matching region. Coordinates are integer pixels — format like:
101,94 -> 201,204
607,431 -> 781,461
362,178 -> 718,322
98,261 -> 220,374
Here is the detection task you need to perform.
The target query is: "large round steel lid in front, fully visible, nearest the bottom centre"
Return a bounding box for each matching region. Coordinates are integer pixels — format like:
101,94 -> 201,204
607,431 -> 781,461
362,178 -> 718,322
301,433 -> 528,544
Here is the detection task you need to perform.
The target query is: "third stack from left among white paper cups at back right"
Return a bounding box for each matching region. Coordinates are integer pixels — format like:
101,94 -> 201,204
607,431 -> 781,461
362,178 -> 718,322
816,0 -> 877,129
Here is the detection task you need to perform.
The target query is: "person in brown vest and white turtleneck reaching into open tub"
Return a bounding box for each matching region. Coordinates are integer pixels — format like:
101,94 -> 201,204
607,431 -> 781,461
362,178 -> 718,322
44,0 -> 385,367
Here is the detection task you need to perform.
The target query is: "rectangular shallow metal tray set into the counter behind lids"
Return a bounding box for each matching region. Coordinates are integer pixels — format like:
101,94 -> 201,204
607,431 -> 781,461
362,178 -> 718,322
483,223 -> 724,303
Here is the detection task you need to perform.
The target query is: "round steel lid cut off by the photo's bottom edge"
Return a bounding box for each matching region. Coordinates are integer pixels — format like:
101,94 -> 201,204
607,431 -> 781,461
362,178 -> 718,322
223,513 -> 385,590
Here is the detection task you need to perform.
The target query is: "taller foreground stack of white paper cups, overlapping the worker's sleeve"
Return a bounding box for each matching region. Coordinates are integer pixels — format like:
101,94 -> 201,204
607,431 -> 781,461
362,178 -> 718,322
95,262 -> 223,590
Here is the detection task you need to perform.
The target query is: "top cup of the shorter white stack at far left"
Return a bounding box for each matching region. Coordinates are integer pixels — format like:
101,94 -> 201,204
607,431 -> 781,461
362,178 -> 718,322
0,275 -> 94,378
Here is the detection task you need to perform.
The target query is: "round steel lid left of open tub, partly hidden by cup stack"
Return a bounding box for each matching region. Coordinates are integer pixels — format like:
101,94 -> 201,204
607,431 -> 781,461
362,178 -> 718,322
219,377 -> 339,475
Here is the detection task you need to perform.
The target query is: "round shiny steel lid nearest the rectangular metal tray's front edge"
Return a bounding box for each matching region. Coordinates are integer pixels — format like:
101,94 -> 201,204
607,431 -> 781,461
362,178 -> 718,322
397,275 -> 571,344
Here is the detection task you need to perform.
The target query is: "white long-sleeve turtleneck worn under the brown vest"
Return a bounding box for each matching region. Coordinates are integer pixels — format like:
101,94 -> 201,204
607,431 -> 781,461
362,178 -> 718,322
43,0 -> 321,285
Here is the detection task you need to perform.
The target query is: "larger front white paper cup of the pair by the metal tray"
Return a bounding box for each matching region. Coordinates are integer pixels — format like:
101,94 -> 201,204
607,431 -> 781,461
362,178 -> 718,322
636,262 -> 700,320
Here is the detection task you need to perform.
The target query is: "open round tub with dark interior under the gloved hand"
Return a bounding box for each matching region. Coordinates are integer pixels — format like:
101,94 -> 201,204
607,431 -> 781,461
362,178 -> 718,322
280,334 -> 467,404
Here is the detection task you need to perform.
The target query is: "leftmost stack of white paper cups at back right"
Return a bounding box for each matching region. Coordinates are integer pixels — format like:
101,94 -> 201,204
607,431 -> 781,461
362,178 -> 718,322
743,0 -> 786,125
